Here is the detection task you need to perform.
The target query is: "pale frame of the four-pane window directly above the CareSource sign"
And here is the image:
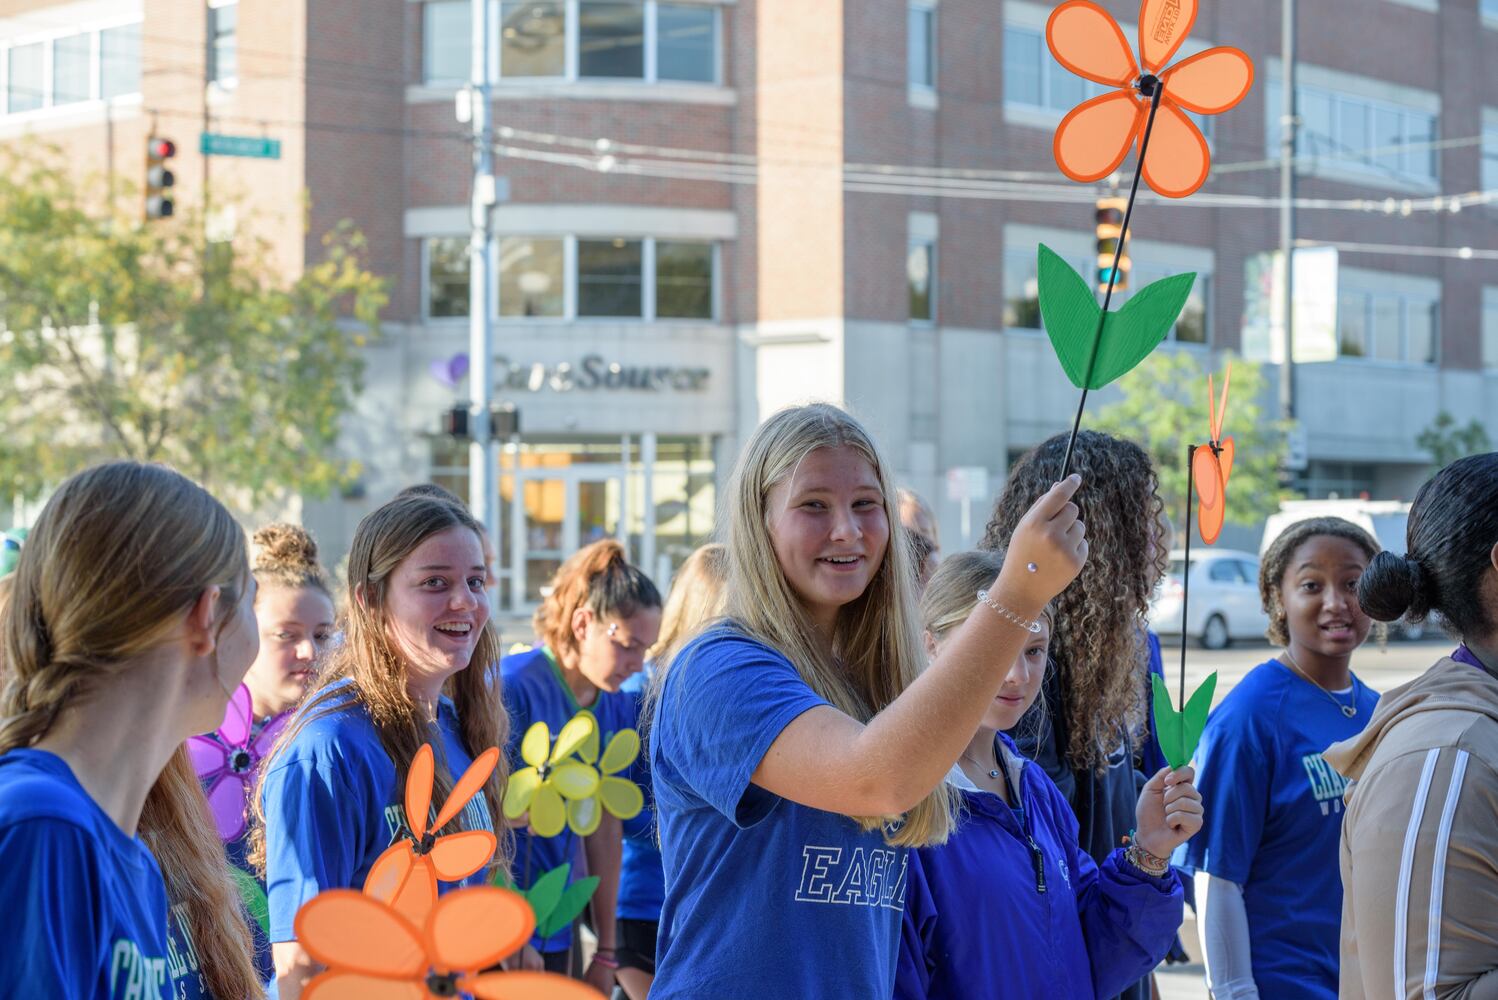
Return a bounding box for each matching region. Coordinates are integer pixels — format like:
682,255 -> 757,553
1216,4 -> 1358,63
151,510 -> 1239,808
419,232 -> 724,326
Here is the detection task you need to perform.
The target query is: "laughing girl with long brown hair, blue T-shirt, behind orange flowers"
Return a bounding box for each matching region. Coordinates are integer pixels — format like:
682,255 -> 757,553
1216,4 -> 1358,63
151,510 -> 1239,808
250,496 -> 508,1000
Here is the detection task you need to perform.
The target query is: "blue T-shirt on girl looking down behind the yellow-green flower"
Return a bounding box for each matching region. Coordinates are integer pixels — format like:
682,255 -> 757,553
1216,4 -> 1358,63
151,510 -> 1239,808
499,647 -> 635,952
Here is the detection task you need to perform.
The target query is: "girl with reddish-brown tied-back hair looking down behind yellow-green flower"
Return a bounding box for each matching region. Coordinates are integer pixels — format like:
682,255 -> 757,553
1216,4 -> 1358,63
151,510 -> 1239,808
500,539 -> 661,996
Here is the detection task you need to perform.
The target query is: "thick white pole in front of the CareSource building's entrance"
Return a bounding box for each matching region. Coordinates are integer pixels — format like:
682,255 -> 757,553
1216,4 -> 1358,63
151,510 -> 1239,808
469,0 -> 499,574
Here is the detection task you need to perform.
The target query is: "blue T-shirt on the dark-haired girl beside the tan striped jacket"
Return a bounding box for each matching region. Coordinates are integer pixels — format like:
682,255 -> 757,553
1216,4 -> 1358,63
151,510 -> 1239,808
1176,660 -> 1378,1000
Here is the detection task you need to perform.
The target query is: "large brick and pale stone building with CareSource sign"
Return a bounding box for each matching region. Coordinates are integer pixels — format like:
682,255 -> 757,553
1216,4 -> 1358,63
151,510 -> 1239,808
0,0 -> 1498,606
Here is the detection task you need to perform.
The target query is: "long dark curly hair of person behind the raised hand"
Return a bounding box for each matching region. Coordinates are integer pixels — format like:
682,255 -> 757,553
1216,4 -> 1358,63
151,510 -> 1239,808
980,431 -> 1168,771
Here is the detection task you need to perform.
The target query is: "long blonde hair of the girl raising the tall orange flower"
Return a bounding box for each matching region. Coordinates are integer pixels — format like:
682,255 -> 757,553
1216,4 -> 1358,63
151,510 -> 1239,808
653,403 -> 956,847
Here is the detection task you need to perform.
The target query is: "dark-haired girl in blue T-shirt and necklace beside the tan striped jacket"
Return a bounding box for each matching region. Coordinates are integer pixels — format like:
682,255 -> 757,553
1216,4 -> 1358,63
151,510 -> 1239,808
1182,518 -> 1378,1000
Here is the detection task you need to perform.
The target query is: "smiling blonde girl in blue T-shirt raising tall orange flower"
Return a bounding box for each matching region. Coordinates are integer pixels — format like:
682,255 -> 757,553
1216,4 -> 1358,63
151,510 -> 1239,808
647,404 -> 1088,1000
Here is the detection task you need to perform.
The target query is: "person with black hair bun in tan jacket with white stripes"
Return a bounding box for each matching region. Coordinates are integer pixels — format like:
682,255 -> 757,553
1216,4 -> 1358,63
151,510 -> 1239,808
1326,452 -> 1498,1000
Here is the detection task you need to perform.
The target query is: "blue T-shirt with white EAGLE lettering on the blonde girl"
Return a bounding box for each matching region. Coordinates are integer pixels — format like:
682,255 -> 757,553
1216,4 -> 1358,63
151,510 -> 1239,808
650,626 -> 908,1000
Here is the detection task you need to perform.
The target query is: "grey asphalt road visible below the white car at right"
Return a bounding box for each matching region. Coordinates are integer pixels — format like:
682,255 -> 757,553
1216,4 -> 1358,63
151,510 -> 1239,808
1155,639 -> 1455,1000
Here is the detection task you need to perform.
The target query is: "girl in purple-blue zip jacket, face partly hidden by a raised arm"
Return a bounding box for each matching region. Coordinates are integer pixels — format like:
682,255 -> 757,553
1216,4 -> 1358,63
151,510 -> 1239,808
894,552 -> 1201,1000
